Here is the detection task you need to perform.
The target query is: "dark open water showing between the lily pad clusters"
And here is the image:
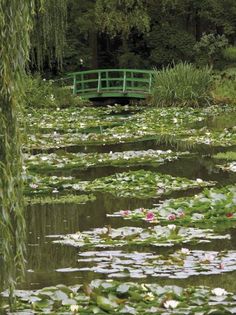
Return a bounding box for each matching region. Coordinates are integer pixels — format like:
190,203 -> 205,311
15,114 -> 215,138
11,107 -> 236,291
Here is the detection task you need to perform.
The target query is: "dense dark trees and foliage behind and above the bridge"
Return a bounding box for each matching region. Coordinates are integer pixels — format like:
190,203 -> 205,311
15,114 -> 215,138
61,0 -> 236,71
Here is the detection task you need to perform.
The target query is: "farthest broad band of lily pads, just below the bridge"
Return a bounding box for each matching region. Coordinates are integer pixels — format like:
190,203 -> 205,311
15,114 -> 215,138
24,106 -> 236,149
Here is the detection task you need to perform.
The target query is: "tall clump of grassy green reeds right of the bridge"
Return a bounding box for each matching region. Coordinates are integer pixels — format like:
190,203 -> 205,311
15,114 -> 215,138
151,63 -> 212,106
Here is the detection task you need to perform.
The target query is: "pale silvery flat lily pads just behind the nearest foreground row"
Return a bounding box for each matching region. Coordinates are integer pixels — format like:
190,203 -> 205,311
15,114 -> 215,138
73,248 -> 236,279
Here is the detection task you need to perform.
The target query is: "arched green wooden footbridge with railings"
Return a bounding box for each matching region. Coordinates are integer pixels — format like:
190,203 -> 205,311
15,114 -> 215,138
69,69 -> 154,99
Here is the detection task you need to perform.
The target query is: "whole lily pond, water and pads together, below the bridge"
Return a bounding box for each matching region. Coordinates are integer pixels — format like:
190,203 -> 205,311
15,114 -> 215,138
1,105 -> 236,314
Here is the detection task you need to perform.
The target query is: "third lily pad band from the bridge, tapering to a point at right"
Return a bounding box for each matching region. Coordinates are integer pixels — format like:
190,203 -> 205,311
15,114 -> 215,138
25,170 -> 215,198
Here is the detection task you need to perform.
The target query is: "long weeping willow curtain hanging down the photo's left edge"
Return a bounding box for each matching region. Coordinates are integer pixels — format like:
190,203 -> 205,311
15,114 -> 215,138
0,0 -> 66,308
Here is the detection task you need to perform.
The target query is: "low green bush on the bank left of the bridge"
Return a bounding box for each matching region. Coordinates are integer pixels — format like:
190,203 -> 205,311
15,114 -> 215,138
24,75 -> 90,108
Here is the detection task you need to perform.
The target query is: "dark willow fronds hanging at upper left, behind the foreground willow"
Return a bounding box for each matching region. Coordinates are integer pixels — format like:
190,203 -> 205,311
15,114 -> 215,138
31,0 -> 67,69
